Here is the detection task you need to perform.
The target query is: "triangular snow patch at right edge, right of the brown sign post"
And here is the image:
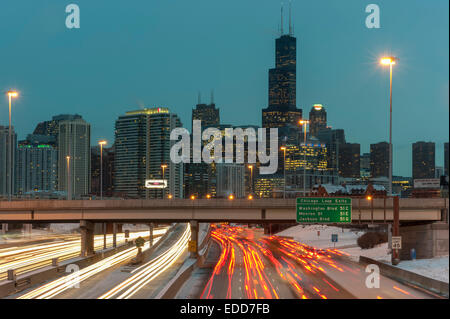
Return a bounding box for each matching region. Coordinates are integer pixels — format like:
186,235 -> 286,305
397,256 -> 449,283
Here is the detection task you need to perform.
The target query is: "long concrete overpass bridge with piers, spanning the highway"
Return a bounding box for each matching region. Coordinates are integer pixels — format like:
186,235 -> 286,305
0,198 -> 449,256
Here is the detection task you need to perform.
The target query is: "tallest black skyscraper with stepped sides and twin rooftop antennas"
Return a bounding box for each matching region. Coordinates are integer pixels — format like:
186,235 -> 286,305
262,15 -> 302,128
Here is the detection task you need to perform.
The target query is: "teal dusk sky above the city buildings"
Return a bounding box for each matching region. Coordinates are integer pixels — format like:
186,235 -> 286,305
0,0 -> 449,176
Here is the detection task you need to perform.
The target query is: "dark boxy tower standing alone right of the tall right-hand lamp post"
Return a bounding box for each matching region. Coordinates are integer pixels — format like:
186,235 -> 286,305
412,142 -> 436,179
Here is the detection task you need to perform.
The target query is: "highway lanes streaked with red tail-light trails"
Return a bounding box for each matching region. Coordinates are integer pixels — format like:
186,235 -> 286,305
200,225 -> 440,299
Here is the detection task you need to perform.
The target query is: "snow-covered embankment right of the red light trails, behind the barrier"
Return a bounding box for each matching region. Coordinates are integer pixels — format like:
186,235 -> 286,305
276,225 -> 449,282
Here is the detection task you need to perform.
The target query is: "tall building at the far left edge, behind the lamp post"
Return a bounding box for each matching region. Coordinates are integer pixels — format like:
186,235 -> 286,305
0,126 -> 17,196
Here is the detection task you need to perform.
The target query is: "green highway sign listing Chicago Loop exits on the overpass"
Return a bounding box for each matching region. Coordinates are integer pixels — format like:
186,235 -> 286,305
297,197 -> 352,224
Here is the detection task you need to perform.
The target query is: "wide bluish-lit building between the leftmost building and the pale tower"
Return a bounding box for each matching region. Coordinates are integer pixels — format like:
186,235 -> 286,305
16,134 -> 58,195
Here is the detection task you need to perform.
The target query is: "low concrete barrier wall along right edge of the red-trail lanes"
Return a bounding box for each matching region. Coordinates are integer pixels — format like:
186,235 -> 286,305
359,256 -> 449,298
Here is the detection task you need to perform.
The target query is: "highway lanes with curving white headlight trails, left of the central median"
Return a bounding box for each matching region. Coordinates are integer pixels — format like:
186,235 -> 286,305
15,224 -> 191,299
